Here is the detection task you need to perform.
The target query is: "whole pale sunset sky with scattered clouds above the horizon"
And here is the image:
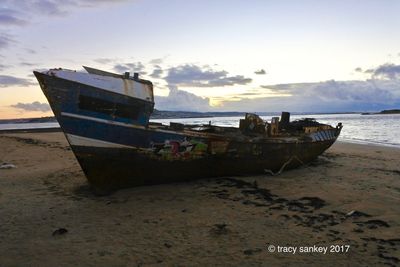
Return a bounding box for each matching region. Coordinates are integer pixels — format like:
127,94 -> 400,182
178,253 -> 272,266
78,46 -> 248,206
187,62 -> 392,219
0,0 -> 400,119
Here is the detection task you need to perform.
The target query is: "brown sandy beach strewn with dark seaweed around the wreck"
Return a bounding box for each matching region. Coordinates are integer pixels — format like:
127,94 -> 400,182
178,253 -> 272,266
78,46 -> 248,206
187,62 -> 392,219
0,132 -> 400,266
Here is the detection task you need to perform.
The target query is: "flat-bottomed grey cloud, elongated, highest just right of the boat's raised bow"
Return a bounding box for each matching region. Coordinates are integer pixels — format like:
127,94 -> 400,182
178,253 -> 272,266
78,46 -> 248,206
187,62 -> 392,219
165,64 -> 252,87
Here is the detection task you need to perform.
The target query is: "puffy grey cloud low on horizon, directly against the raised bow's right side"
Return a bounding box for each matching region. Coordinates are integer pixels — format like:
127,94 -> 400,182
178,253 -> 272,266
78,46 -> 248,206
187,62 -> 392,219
155,86 -> 210,111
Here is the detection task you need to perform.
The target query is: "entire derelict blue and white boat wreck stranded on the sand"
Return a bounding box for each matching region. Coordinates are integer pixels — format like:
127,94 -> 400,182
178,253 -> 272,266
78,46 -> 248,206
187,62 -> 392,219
34,67 -> 342,192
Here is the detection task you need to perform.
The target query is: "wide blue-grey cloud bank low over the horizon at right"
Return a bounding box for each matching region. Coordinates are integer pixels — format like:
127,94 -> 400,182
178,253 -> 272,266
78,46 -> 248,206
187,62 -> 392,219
221,79 -> 400,112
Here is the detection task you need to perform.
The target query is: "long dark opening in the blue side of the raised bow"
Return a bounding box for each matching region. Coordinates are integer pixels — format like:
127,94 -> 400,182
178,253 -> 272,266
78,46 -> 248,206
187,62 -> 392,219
79,95 -> 144,120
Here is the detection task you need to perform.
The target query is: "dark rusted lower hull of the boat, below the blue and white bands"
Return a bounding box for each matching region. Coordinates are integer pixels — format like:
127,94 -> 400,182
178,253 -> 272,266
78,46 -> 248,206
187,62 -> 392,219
72,140 -> 335,195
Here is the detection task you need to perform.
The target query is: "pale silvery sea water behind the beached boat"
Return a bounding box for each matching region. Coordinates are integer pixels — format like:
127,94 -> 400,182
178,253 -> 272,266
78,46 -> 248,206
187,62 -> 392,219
0,114 -> 400,148
